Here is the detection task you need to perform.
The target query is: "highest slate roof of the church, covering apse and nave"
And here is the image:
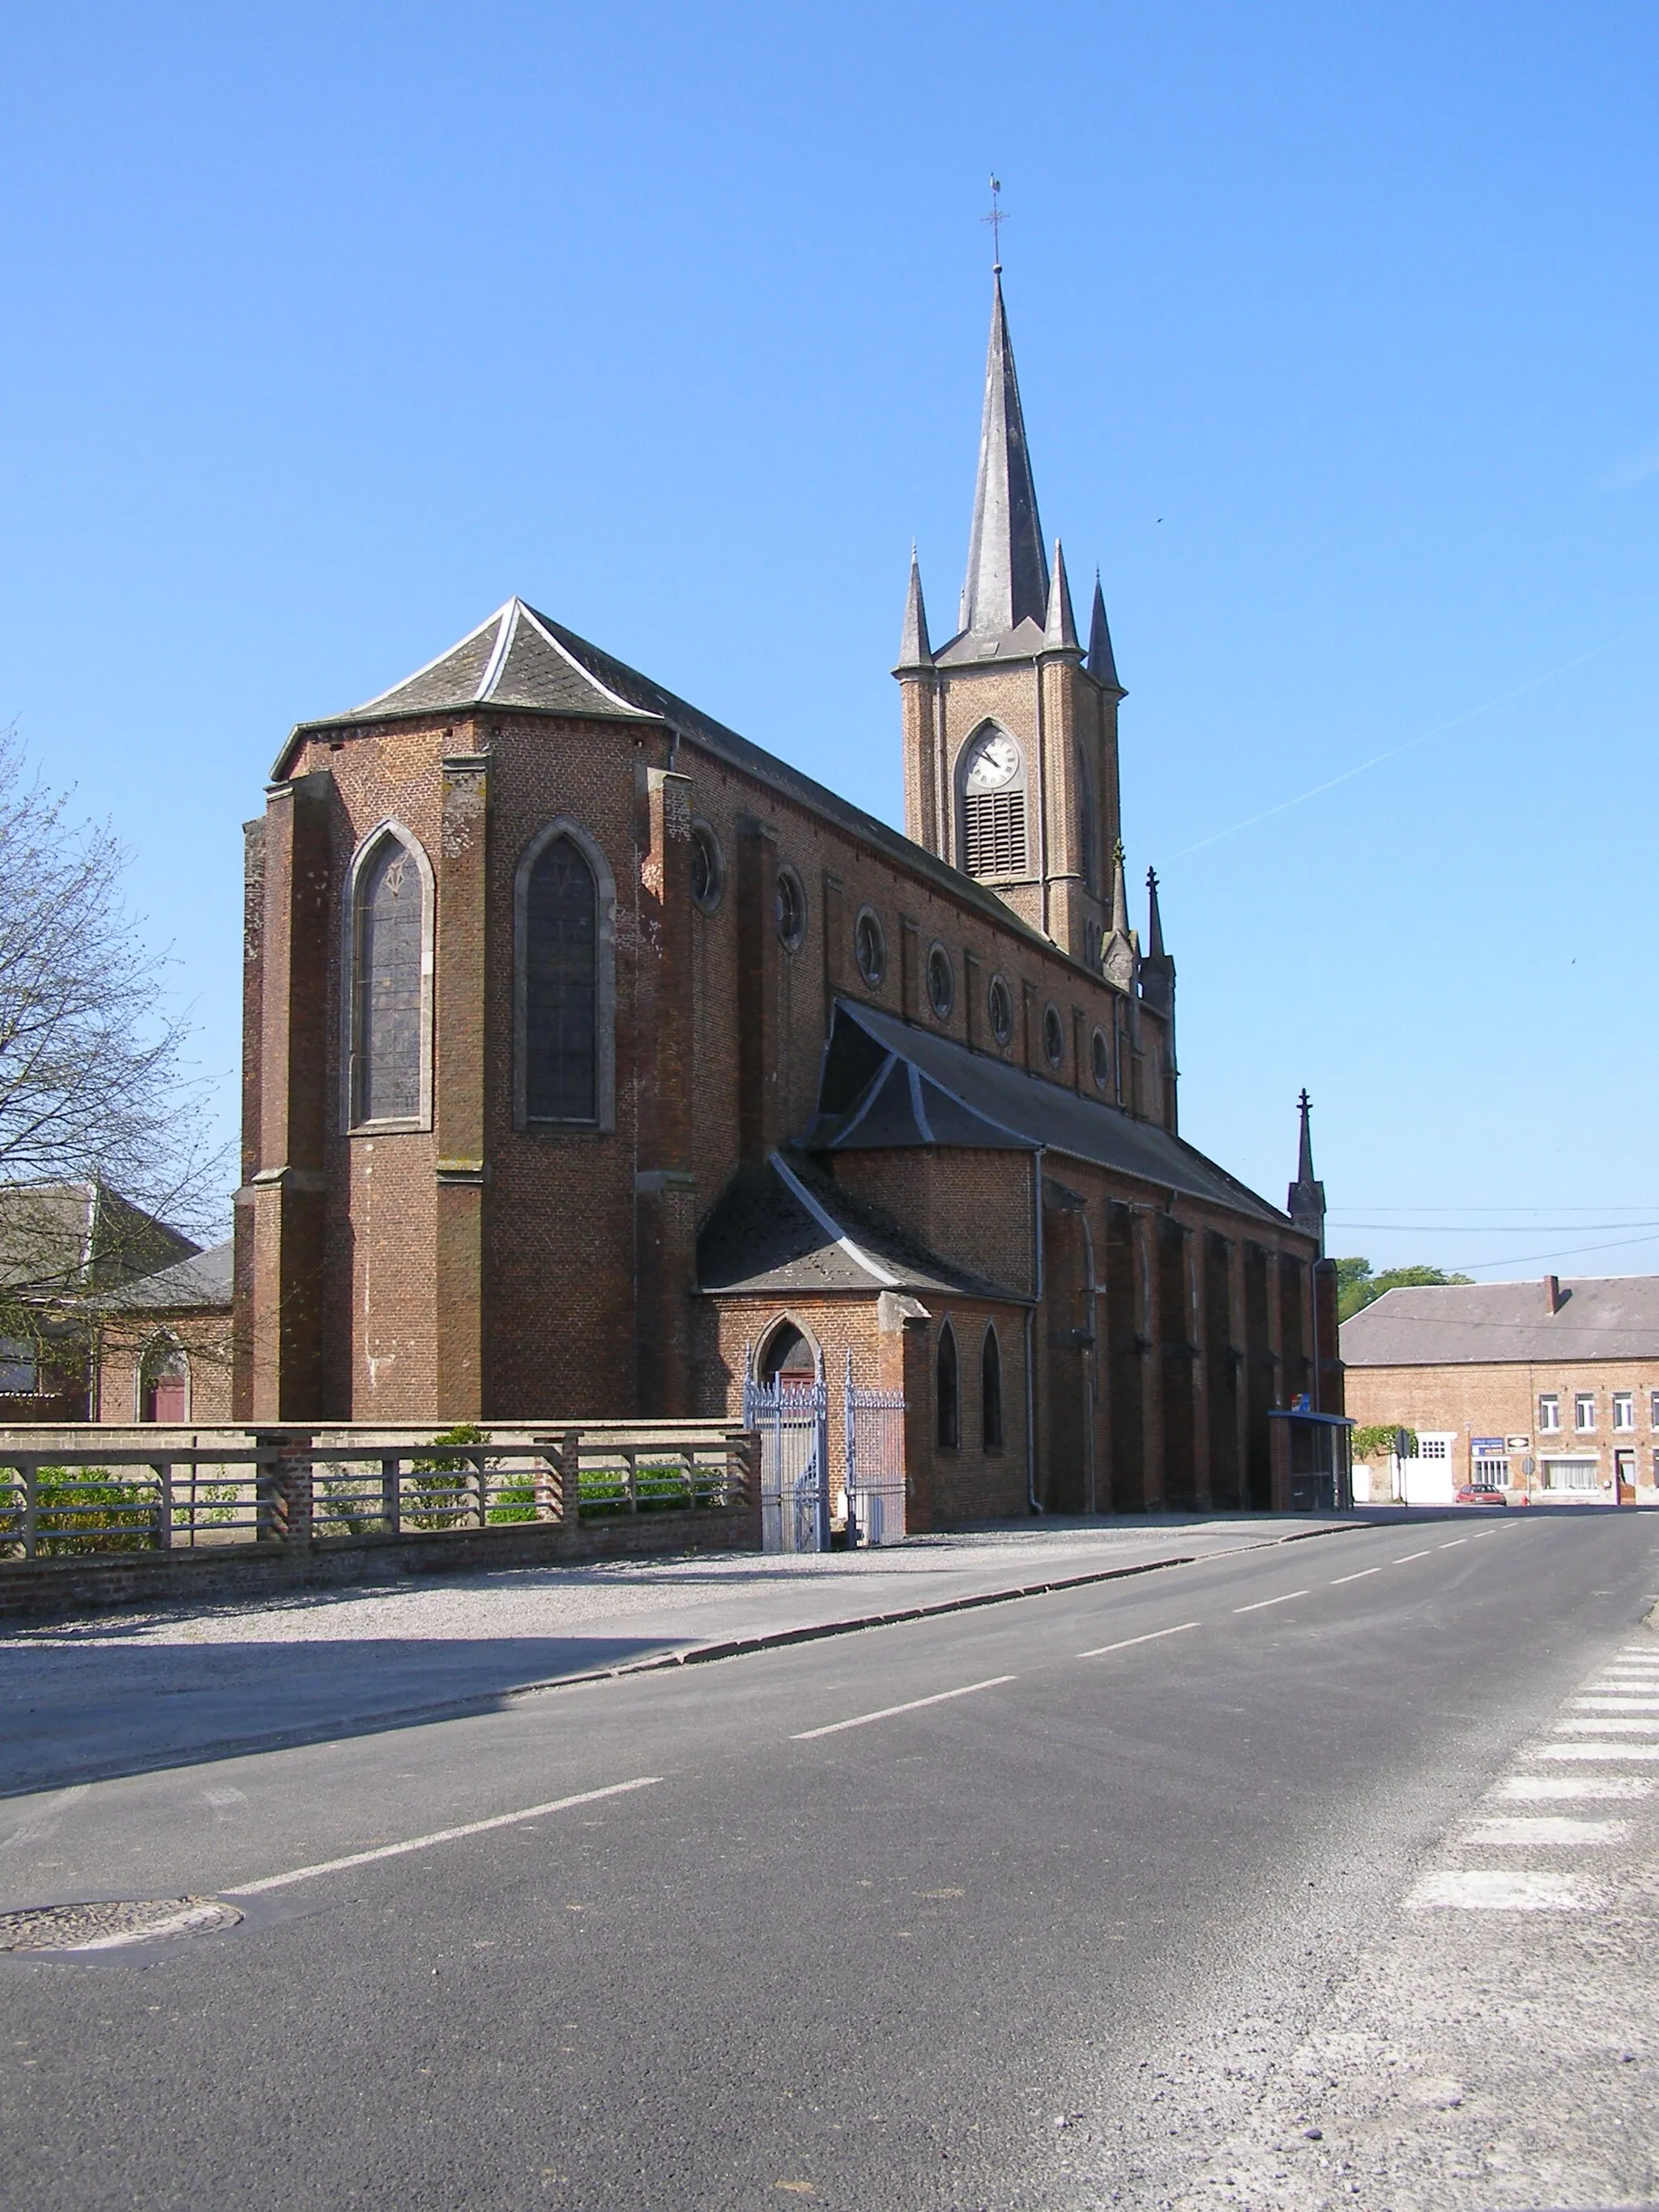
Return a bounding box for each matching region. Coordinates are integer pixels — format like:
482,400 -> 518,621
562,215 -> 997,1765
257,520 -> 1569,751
272,599 -> 1070,974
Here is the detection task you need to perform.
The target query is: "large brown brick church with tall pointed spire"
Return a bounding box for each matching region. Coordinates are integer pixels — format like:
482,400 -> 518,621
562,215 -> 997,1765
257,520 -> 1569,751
234,275 -> 1341,1526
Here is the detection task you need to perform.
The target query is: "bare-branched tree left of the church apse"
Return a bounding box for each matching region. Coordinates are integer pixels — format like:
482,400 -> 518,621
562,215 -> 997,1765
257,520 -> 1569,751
0,727 -> 228,1334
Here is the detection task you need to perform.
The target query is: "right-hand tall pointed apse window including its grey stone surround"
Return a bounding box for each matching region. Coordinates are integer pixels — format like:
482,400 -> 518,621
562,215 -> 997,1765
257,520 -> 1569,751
514,820 -> 615,1131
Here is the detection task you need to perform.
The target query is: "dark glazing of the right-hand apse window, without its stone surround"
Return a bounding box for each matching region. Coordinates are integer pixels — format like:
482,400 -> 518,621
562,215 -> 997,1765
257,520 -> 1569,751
524,836 -> 599,1122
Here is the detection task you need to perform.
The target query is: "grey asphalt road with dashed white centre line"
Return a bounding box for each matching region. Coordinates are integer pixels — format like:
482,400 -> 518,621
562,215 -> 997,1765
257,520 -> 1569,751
0,1513 -> 1659,2212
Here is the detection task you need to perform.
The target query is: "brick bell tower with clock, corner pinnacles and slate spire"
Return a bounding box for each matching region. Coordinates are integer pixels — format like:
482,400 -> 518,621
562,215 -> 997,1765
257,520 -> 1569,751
893,263 -> 1124,966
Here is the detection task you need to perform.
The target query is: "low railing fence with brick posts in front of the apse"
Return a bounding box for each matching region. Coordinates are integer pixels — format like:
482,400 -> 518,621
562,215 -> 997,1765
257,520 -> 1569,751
0,1422 -> 754,1559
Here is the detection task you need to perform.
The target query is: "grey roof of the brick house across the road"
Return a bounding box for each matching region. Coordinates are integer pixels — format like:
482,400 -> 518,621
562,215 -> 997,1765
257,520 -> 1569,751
1341,1274 -> 1659,1367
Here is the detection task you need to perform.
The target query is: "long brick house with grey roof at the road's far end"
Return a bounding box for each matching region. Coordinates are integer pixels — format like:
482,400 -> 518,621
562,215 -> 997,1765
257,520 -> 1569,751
1343,1274 -> 1659,1504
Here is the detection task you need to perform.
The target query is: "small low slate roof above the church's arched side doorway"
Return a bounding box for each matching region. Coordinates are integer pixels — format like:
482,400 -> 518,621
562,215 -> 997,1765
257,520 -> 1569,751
697,1153 -> 1030,1305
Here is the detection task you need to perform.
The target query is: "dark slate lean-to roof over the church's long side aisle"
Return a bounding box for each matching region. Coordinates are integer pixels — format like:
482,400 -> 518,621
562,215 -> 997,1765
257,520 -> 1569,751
801,998 -> 1290,1228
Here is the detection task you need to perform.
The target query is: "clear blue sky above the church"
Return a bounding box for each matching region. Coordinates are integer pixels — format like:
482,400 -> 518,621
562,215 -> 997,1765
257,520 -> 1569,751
0,0 -> 1659,1276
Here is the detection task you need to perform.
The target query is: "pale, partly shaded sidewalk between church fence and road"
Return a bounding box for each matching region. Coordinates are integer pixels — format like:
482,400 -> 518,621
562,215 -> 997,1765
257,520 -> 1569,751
0,1513 -> 1398,1794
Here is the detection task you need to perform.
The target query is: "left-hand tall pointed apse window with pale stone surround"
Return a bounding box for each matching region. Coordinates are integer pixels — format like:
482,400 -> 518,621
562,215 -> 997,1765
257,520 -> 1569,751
349,825 -> 431,1128
